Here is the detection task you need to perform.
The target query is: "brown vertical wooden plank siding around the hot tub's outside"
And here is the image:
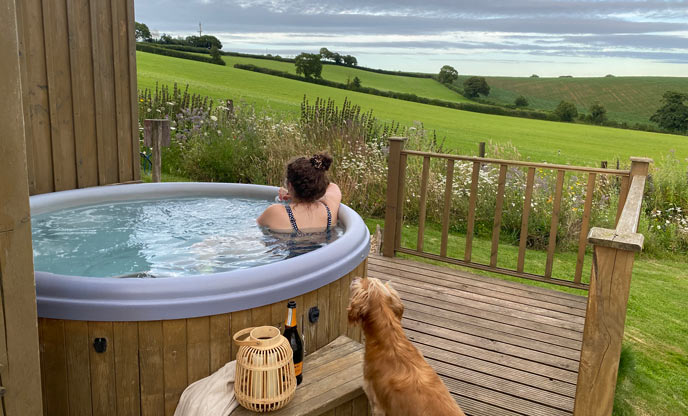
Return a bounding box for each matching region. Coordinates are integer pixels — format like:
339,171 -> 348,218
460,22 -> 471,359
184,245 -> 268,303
39,261 -> 366,416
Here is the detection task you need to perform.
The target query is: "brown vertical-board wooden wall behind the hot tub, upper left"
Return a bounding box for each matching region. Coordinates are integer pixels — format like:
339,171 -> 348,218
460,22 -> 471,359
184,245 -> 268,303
17,0 -> 139,194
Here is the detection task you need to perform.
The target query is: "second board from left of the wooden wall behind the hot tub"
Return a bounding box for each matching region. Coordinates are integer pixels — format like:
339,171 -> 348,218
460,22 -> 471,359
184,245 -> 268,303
43,1 -> 77,191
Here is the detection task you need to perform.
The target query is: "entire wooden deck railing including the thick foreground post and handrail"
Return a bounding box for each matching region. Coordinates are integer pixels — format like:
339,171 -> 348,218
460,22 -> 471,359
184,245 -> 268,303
383,137 -> 652,416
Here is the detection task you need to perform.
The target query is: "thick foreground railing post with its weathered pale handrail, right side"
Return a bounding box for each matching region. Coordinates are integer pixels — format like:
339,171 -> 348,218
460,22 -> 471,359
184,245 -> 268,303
573,158 -> 651,416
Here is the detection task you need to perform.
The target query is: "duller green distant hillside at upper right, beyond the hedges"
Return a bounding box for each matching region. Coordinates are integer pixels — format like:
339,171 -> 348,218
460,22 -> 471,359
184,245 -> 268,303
456,76 -> 688,124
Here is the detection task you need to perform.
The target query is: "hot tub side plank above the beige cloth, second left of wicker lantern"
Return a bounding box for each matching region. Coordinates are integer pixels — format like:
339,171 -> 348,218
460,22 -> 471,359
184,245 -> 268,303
186,316 -> 210,384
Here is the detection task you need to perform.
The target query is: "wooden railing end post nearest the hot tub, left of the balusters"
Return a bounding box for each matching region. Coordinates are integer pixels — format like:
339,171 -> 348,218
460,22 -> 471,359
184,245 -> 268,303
382,137 -> 406,257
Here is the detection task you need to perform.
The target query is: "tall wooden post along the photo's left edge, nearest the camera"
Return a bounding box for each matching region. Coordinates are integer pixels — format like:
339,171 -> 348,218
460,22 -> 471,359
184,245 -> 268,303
0,0 -> 43,416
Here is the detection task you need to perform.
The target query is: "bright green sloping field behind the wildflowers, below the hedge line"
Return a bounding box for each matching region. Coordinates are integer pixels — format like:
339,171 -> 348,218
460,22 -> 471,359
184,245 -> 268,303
136,52 -> 688,165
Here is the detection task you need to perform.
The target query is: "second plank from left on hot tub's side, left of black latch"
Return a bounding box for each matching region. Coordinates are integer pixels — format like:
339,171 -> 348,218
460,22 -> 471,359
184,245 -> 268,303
63,321 -> 91,416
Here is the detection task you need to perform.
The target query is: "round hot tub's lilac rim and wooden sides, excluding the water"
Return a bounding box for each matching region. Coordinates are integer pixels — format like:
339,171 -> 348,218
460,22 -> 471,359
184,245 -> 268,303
31,183 -> 369,415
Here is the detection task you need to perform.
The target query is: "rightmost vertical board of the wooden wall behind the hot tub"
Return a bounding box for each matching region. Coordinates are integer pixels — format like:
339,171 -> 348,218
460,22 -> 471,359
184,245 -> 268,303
111,0 -> 132,182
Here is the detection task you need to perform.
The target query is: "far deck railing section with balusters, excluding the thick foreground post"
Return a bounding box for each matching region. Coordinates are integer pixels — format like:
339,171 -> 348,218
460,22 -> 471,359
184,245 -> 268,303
383,137 -> 647,289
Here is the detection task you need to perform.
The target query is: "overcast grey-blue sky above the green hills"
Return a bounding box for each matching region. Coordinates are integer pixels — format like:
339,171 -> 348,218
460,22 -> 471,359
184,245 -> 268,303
135,0 -> 688,76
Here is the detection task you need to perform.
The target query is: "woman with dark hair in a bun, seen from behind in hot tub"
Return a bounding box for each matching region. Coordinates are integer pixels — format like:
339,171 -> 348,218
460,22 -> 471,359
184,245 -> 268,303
257,153 -> 342,244
